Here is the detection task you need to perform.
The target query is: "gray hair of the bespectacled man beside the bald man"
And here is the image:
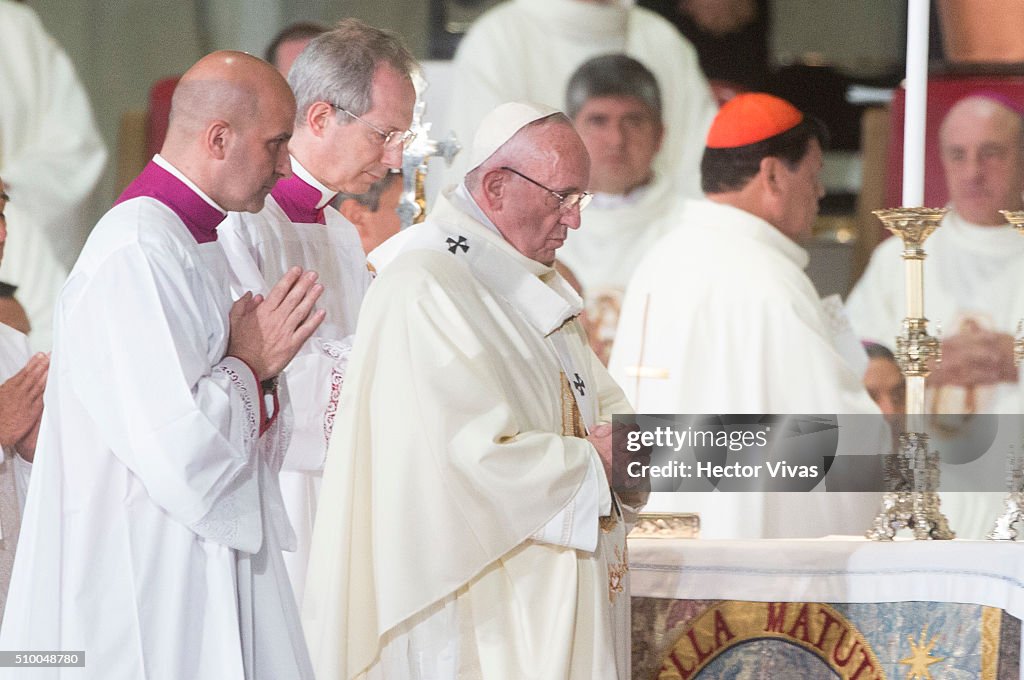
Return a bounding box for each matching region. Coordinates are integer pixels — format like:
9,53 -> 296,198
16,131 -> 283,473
288,18 -> 417,127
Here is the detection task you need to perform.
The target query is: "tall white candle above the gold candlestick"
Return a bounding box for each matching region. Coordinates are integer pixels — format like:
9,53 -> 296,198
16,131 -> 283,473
902,0 -> 929,208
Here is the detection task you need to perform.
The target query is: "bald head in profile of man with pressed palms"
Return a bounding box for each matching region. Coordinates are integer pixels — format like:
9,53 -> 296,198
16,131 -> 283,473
160,50 -> 295,212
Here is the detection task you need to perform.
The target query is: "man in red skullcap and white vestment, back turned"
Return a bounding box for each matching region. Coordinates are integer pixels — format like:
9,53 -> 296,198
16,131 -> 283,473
609,93 -> 881,539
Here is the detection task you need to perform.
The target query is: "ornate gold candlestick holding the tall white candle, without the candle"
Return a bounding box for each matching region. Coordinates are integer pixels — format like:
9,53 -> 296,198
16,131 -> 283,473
866,208 -> 955,541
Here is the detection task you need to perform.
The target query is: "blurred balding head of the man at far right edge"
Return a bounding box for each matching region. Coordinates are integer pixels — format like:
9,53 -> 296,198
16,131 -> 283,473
939,95 -> 1024,225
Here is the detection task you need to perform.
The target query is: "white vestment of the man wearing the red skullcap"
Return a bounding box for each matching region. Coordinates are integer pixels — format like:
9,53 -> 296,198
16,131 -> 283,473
608,200 -> 879,539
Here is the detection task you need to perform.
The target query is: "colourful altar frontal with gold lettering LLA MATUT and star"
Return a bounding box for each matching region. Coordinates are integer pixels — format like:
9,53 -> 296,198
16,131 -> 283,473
633,597 -> 1021,680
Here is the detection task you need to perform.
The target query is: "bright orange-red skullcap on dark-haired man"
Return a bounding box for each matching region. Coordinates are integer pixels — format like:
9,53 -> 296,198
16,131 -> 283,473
707,92 -> 804,148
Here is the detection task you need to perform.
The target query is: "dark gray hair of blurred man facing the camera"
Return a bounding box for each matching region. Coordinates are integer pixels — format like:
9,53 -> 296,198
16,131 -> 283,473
565,54 -> 662,121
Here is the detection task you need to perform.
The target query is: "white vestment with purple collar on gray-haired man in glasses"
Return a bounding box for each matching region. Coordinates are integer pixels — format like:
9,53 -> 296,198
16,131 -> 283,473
217,158 -> 371,602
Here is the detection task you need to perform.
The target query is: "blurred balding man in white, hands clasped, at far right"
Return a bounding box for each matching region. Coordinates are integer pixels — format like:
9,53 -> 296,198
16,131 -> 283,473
846,93 -> 1024,539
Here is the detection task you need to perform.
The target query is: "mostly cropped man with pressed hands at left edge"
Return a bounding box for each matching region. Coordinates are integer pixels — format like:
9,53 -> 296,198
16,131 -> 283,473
0,179 -> 50,615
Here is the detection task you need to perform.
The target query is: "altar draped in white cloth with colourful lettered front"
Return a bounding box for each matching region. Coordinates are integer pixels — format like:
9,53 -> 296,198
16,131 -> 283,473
629,537 -> 1024,680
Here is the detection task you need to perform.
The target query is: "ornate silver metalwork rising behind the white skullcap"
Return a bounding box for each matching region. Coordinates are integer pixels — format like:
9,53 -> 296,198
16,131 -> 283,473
398,74 -> 462,228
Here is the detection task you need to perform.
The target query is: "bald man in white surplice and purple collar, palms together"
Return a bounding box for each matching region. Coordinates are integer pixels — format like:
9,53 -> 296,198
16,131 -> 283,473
0,51 -> 324,680
